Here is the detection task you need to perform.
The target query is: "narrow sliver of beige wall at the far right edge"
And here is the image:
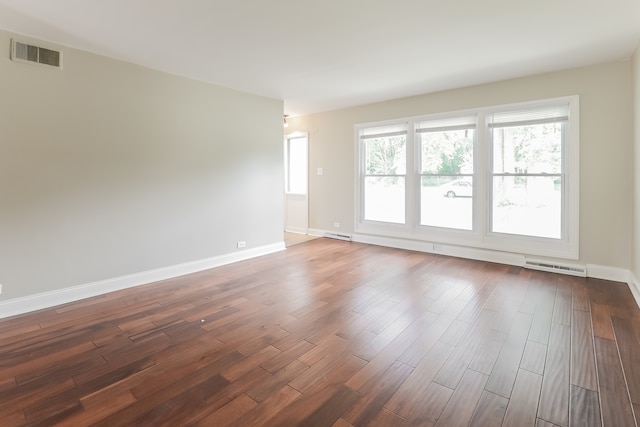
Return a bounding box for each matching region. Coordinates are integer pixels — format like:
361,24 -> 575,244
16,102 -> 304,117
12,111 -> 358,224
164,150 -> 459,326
631,44 -> 640,280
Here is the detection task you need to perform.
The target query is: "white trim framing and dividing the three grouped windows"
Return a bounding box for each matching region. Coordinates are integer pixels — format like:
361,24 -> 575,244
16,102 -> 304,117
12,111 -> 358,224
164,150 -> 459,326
354,95 -> 580,260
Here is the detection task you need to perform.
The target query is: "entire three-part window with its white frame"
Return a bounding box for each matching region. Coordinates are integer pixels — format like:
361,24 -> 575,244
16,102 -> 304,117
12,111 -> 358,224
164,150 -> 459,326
356,97 -> 579,259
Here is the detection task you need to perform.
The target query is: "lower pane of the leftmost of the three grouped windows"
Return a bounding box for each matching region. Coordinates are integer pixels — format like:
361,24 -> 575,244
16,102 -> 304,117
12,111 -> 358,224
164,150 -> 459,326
364,176 -> 405,224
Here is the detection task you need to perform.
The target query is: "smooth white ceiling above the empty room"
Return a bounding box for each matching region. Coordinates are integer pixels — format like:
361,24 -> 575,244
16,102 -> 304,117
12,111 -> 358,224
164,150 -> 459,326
0,0 -> 640,115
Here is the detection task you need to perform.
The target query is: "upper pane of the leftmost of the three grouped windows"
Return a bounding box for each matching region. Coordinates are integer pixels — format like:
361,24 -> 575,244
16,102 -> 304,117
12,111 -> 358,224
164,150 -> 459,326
364,135 -> 407,175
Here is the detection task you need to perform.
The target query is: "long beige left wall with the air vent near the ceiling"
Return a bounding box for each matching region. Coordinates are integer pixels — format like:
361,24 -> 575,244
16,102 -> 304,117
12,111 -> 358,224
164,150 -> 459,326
0,32 -> 283,300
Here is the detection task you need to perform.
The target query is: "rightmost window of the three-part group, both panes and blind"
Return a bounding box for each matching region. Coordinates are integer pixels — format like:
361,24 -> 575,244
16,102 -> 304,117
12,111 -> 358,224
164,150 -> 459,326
489,105 -> 569,239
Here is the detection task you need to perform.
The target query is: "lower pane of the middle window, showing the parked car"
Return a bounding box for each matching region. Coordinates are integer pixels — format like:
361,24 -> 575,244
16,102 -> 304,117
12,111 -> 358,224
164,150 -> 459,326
420,176 -> 473,230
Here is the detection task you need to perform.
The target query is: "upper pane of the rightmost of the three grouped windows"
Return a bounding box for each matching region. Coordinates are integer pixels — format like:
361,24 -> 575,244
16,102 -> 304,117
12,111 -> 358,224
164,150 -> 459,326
493,123 -> 562,173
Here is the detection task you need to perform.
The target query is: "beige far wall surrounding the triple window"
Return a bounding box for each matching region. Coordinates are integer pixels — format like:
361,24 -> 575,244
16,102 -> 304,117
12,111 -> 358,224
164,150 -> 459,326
289,61 -> 633,268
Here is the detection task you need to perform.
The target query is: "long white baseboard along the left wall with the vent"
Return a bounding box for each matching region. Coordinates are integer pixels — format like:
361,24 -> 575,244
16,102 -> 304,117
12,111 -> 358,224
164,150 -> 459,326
0,242 -> 285,319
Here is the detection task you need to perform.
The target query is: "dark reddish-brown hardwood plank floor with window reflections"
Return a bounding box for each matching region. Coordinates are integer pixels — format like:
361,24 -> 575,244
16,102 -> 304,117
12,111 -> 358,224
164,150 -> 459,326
0,239 -> 640,427
